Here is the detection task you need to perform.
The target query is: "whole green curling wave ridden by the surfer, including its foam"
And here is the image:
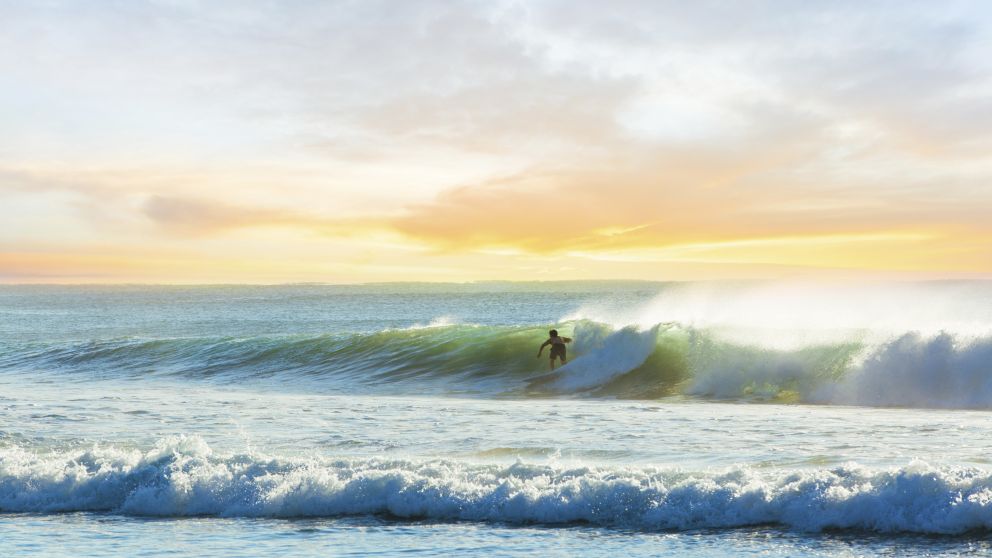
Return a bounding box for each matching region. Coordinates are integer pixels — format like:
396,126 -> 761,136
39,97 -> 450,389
0,320 -> 992,408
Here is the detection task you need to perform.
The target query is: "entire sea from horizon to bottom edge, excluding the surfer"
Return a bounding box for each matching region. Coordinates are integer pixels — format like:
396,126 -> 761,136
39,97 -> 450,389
0,281 -> 992,556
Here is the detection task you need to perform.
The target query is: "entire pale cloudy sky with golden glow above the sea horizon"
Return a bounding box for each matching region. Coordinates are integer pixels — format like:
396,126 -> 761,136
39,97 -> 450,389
0,0 -> 992,283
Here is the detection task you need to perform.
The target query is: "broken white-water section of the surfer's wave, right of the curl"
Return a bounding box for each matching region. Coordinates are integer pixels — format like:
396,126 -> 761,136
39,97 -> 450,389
684,333 -> 992,409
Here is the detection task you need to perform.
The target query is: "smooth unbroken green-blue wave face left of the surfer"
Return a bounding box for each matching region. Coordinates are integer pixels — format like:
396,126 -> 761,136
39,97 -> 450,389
0,323 -> 547,389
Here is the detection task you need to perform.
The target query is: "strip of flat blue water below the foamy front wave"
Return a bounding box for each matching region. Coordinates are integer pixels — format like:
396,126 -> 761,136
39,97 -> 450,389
7,513 -> 992,557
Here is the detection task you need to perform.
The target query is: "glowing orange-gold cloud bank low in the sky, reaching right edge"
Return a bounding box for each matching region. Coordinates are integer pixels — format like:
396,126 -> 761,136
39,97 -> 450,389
386,144 -> 992,268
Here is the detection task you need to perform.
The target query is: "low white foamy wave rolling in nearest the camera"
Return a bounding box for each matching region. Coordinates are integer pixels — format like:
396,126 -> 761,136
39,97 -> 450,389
0,437 -> 992,534
